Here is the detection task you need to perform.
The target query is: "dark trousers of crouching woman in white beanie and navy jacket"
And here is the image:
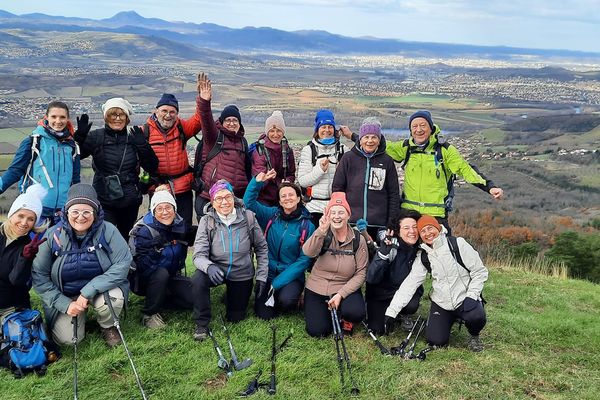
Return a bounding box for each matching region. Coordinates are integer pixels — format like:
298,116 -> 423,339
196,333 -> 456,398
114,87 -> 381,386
142,268 -> 194,315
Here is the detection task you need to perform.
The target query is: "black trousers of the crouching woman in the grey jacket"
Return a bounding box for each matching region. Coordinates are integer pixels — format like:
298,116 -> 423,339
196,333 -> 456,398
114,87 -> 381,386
192,270 -> 252,326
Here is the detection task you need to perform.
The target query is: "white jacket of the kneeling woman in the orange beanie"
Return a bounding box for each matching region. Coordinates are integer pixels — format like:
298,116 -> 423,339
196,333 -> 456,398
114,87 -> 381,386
385,227 -> 488,318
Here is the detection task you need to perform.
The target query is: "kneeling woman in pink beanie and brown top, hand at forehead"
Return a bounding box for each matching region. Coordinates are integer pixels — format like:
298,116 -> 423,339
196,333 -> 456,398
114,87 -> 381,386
302,192 -> 369,337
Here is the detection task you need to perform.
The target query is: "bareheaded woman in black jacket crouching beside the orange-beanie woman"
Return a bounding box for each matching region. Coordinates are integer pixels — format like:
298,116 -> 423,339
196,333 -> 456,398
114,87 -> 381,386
365,209 -> 424,334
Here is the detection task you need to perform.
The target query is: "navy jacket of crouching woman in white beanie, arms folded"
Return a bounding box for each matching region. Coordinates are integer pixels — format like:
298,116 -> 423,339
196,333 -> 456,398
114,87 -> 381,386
130,212 -> 187,277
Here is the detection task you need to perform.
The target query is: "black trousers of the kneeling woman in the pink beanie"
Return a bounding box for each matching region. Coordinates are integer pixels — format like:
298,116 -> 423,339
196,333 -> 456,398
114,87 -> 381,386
304,288 -> 366,337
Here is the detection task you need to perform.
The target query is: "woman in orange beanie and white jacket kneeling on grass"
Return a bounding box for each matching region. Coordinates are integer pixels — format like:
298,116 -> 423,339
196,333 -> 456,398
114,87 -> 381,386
385,215 -> 488,351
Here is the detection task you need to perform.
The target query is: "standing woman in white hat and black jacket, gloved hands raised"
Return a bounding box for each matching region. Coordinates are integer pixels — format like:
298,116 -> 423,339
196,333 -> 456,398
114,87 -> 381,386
75,97 -> 158,240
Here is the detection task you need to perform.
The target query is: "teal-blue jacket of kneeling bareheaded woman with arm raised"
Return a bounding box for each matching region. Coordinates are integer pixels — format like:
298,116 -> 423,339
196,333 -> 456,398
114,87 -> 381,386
244,178 -> 315,290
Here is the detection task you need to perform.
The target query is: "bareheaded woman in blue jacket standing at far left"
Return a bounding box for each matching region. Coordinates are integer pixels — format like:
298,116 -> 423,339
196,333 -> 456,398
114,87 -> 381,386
0,101 -> 86,224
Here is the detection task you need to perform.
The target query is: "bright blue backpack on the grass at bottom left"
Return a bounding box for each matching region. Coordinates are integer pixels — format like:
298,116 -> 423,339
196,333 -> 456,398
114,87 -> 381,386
0,309 -> 49,378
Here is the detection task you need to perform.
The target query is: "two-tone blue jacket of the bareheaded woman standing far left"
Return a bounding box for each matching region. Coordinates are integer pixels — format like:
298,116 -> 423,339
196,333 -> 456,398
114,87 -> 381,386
0,125 -> 81,217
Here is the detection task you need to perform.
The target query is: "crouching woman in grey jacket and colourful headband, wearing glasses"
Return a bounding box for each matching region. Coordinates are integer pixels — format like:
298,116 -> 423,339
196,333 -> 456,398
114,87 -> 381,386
192,179 -> 269,340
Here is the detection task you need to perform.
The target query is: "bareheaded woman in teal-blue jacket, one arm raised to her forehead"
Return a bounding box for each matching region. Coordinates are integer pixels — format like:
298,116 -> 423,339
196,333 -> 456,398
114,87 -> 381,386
244,170 -> 315,319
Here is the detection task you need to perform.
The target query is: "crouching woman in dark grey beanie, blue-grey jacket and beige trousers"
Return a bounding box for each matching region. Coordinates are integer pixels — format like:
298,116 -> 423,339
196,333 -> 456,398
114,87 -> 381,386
32,183 -> 132,347
